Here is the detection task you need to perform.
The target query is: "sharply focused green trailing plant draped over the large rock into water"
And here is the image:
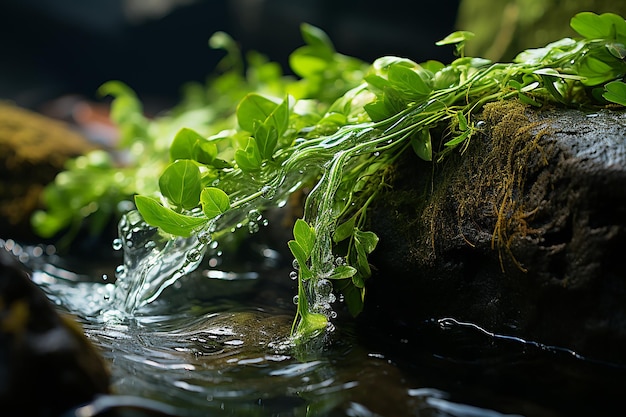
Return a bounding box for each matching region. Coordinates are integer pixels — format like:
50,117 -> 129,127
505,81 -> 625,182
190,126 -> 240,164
33,13 -> 626,338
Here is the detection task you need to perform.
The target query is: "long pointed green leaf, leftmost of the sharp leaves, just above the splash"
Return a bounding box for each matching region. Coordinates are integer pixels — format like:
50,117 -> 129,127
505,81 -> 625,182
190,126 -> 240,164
135,195 -> 207,237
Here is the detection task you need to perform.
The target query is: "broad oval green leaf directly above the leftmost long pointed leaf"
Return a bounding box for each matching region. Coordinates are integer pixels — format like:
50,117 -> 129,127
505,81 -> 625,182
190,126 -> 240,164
159,159 -> 202,210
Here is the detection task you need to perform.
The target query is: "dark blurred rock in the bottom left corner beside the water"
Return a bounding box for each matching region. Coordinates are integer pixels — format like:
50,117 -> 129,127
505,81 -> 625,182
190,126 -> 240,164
0,245 -> 109,417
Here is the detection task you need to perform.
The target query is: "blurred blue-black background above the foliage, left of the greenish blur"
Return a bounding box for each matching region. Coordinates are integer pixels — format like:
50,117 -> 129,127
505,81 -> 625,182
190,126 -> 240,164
0,0 -> 459,110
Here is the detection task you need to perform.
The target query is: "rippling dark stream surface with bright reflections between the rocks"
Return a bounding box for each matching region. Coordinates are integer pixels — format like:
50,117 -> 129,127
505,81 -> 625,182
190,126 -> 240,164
0,237 -> 626,417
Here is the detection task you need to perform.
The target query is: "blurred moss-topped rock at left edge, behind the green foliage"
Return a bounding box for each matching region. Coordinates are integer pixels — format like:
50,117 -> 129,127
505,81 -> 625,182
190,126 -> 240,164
0,101 -> 95,240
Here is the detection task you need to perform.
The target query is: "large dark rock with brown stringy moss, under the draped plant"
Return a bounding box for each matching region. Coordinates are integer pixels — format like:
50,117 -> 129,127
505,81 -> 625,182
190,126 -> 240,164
365,101 -> 626,363
